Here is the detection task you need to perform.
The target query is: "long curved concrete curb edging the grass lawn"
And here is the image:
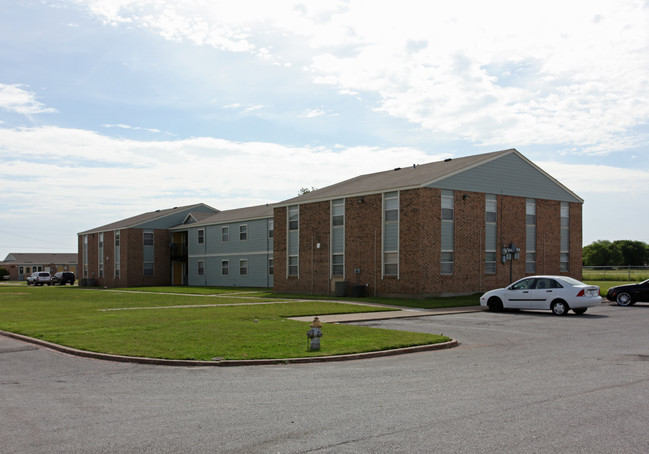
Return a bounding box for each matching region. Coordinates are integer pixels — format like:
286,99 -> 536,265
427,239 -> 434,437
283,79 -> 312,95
0,331 -> 458,367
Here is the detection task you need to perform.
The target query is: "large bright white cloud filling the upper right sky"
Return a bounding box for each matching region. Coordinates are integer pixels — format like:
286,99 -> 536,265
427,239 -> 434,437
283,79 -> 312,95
71,0 -> 649,153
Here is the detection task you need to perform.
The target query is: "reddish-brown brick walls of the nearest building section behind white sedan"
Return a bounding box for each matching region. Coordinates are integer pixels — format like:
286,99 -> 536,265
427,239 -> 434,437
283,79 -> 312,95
274,188 -> 582,296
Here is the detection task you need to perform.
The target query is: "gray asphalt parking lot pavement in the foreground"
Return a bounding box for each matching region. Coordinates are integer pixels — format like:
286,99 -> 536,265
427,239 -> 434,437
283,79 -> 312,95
0,304 -> 649,453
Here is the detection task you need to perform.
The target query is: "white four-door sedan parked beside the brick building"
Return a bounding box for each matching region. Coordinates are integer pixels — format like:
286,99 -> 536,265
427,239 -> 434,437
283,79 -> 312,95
480,276 -> 602,315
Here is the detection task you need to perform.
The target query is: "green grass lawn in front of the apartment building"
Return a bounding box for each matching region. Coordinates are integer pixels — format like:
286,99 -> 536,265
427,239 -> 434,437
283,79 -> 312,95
0,285 -> 448,360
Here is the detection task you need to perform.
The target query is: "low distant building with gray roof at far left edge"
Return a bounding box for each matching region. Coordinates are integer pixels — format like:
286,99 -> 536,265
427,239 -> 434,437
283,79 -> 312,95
0,252 -> 78,281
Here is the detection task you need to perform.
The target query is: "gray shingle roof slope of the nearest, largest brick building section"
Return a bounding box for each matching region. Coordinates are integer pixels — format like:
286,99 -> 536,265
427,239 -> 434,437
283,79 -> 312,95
277,148 -> 520,206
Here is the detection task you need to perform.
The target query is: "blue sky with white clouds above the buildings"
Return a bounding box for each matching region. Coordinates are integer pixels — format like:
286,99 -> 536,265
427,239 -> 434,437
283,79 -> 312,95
0,0 -> 649,260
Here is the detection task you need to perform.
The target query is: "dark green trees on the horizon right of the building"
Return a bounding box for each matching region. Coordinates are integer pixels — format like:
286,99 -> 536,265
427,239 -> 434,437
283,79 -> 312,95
582,240 -> 649,266
